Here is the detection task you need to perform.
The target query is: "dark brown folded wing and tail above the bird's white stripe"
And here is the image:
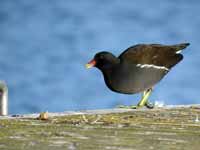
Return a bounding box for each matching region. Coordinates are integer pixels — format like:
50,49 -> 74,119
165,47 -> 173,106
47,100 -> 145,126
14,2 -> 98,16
118,43 -> 189,68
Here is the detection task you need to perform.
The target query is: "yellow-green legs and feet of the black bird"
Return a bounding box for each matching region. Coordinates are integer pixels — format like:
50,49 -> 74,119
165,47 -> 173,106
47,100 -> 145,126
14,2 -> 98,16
119,88 -> 154,109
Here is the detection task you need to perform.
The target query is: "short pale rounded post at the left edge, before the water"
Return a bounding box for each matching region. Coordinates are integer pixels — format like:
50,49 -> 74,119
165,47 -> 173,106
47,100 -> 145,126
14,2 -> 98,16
0,81 -> 8,116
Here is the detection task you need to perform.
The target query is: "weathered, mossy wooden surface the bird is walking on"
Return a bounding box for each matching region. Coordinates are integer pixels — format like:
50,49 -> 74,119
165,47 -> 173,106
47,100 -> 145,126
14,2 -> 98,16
0,105 -> 200,150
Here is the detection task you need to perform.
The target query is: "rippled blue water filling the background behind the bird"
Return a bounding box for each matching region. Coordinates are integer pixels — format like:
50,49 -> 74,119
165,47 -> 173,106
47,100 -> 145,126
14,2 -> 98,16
0,0 -> 200,113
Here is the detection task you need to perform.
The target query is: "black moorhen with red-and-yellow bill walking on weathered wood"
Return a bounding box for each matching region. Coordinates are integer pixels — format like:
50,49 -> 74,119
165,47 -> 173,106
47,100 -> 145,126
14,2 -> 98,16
86,43 -> 189,108
